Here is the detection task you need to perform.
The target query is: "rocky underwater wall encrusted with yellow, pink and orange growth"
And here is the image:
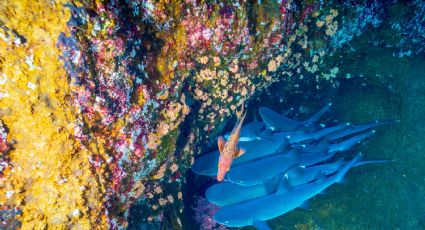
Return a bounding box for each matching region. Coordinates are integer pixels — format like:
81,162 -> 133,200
0,0 -> 425,229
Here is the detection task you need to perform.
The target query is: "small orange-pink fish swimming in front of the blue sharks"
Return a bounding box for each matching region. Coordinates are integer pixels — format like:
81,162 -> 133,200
217,103 -> 246,181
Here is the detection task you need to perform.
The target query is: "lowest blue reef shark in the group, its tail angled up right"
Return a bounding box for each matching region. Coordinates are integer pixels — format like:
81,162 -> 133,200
214,155 -> 360,229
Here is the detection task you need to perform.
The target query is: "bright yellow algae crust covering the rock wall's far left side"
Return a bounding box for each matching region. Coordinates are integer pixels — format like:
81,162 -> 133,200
0,1 -> 107,229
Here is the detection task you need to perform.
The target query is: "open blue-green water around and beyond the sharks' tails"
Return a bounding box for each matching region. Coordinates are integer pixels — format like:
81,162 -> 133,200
185,22 -> 425,229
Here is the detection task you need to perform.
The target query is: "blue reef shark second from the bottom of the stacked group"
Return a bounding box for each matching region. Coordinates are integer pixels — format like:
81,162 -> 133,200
205,159 -> 388,206
